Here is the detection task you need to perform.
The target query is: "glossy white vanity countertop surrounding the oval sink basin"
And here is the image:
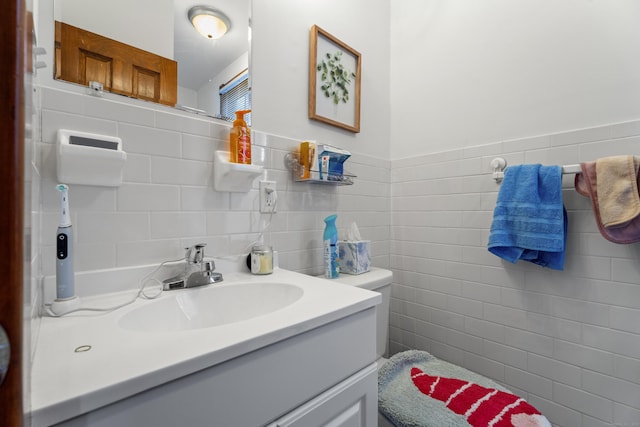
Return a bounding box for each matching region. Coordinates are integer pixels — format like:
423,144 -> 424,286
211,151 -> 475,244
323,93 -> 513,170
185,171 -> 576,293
31,269 -> 381,427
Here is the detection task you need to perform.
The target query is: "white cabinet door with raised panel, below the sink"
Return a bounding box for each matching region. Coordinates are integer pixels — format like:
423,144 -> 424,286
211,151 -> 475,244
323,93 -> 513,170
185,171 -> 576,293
267,363 -> 378,427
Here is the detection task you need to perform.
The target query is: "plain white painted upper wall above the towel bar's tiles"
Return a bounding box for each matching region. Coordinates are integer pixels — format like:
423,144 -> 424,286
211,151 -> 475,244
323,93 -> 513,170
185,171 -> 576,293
391,0 -> 640,159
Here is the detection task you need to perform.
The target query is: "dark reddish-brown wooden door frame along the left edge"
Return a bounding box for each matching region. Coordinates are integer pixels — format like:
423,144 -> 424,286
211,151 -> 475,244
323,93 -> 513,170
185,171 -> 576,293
0,0 -> 30,427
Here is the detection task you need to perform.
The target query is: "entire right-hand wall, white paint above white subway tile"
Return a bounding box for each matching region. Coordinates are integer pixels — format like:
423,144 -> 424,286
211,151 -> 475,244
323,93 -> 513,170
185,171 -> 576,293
391,0 -> 640,427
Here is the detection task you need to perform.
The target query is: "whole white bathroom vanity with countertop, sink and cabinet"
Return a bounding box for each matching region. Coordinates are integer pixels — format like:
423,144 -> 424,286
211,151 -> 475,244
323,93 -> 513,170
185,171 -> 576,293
31,269 -> 380,427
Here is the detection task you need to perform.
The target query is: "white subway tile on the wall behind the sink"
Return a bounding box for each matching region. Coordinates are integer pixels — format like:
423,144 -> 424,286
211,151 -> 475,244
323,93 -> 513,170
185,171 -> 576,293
32,87 -> 391,280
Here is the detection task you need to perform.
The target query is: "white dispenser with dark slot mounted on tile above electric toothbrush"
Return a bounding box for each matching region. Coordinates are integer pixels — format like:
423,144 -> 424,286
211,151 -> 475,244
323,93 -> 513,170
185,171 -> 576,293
56,129 -> 127,187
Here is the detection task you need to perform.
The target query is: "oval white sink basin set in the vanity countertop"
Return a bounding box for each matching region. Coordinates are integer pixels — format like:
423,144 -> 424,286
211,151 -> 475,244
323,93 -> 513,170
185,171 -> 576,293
118,282 -> 304,332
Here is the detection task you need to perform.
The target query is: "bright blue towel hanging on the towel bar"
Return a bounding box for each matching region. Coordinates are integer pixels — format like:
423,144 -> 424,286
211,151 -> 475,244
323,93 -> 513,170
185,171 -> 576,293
488,164 -> 567,270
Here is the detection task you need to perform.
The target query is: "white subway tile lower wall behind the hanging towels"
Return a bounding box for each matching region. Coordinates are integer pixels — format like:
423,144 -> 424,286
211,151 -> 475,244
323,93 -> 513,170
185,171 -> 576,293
390,121 -> 640,427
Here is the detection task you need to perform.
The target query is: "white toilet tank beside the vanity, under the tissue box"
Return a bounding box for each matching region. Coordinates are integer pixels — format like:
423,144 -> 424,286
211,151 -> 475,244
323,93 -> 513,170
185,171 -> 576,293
331,267 -> 393,358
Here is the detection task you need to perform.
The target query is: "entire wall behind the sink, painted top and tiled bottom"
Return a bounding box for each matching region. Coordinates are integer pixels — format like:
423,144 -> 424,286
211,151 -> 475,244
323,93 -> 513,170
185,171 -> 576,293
35,0 -> 390,275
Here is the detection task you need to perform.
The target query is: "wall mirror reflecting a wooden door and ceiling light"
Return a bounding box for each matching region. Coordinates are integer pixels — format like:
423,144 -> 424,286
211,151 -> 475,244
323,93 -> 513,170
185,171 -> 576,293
54,0 -> 251,118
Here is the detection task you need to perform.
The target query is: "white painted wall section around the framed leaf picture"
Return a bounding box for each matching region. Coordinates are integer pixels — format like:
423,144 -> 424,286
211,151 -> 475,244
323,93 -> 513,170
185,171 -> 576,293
251,0 -> 390,159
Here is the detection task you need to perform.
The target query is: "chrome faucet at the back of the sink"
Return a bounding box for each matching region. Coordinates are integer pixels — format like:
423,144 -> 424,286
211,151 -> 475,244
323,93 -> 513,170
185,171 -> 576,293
162,243 -> 223,291
